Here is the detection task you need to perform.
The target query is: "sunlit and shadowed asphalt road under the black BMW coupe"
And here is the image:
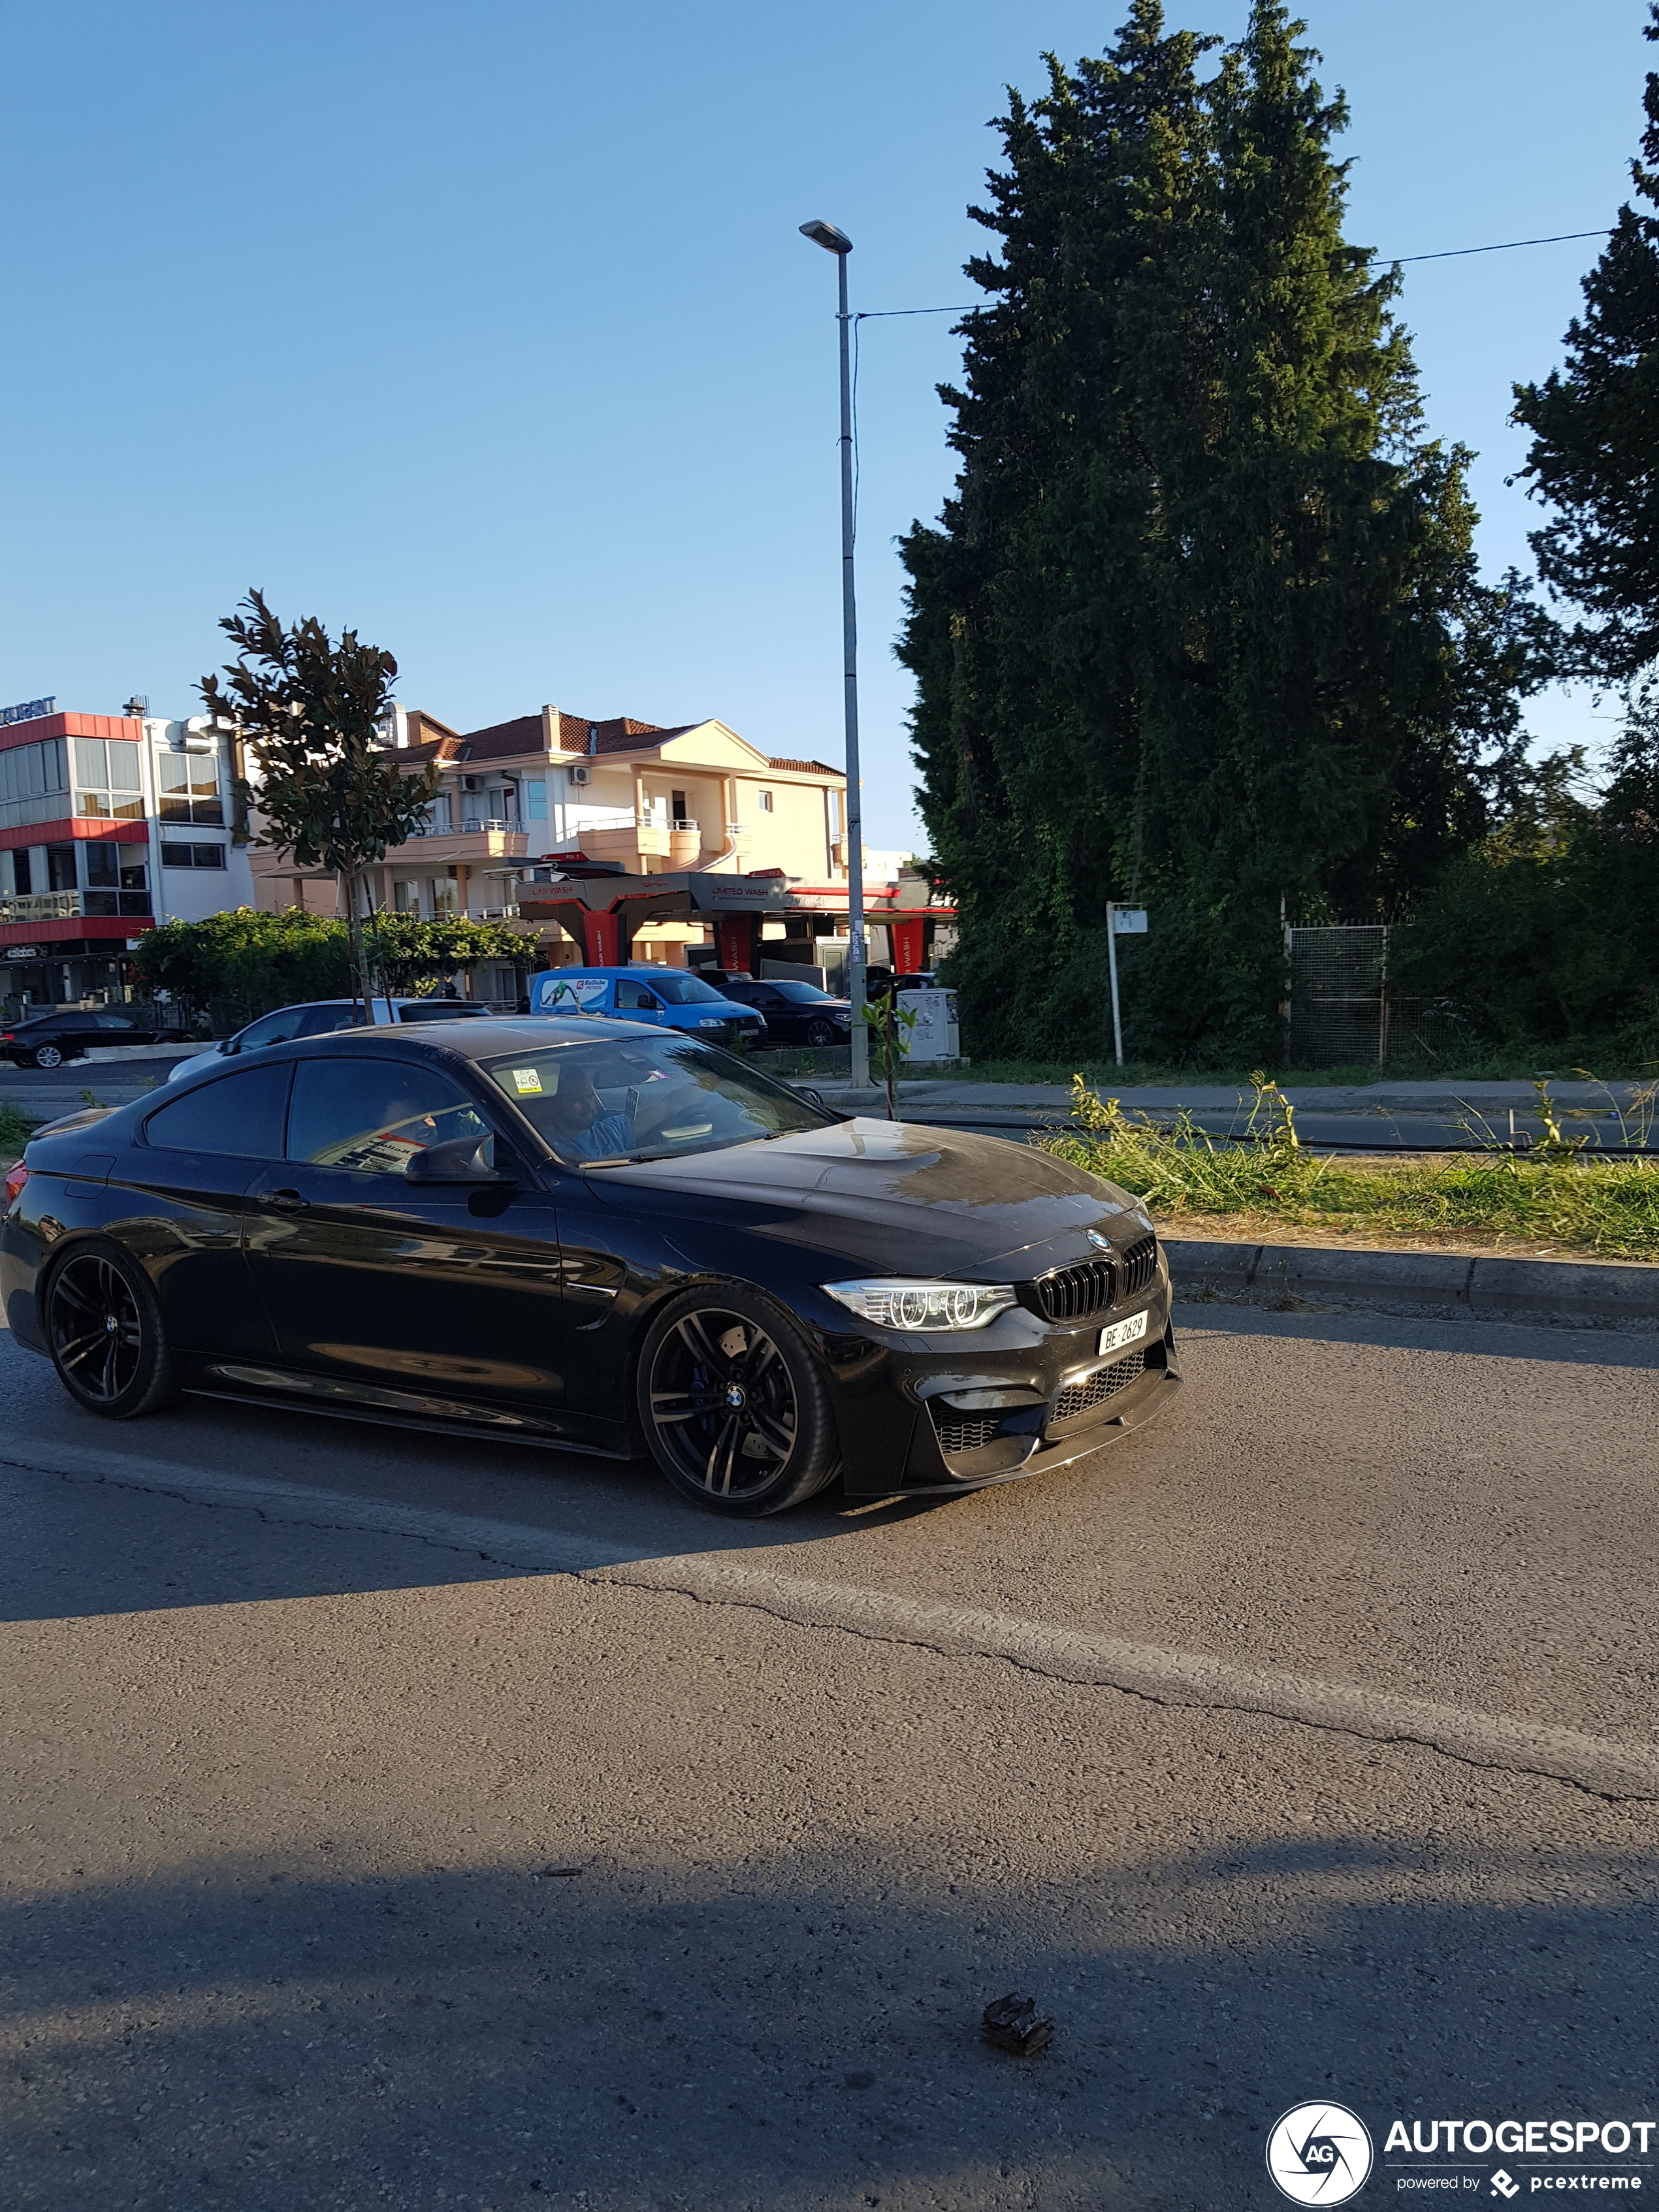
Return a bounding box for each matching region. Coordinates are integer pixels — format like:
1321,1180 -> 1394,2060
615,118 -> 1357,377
0,1307 -> 1659,2212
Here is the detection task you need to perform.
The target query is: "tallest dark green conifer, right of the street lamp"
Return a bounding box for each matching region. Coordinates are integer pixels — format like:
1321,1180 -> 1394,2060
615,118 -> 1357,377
900,0 -> 1513,1055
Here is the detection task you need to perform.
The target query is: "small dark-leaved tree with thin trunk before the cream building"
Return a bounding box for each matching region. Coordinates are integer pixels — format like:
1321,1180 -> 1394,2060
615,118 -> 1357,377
201,590 -> 438,1000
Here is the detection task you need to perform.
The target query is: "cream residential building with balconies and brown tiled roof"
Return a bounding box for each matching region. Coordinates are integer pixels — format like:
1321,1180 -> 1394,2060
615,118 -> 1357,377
254,705 -> 847,978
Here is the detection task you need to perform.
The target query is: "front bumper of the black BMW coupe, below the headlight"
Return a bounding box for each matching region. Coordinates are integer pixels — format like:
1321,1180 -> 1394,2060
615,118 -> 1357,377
825,1263 -> 1181,1498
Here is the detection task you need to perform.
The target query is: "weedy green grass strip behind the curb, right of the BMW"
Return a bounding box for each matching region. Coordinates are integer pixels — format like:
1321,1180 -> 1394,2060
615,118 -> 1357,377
1037,1075 -> 1659,1261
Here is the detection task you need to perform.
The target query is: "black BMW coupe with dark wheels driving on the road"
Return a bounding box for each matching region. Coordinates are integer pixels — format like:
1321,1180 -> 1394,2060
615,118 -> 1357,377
0,1018 -> 1179,1515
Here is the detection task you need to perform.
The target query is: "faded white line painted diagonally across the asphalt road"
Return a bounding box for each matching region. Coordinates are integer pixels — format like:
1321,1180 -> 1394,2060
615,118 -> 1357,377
12,1445 -> 1659,1801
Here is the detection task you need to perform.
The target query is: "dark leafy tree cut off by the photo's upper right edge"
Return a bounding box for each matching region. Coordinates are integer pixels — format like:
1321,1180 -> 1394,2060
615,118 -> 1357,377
1515,5 -> 1659,681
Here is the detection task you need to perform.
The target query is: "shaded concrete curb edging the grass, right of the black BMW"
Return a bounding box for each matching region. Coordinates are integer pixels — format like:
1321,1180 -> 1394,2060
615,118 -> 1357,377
1163,1236 -> 1659,1330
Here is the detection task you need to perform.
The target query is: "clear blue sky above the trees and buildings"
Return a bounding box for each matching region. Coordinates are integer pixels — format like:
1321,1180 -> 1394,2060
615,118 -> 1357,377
0,0 -> 1654,845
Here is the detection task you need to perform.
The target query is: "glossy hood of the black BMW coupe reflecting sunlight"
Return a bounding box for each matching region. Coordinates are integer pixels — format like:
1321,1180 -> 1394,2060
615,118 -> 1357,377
586,1119 -> 1146,1279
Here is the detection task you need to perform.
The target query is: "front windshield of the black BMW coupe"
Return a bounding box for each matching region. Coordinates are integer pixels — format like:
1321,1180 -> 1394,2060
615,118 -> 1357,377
489,1035 -> 834,1166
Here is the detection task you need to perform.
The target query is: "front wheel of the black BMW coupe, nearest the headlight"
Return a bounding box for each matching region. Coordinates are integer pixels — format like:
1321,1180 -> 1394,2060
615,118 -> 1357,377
635,1283 -> 841,1520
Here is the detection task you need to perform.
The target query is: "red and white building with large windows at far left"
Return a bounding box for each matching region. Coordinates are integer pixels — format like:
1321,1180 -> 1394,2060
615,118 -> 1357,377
0,699 -> 254,1018
